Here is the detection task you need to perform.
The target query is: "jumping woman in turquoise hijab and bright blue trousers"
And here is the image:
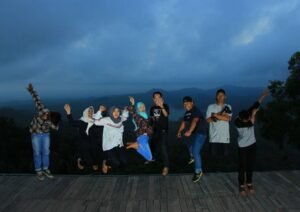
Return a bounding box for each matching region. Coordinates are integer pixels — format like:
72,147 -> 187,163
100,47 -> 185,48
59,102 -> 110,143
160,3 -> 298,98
126,97 -> 153,161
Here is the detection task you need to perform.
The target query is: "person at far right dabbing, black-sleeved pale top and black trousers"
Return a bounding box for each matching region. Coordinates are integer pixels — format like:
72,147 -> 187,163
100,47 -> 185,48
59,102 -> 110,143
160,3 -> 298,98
234,90 -> 269,196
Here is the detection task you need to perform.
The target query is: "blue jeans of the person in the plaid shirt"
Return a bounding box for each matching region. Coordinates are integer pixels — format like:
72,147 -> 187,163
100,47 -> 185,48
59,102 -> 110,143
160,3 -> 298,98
31,133 -> 50,172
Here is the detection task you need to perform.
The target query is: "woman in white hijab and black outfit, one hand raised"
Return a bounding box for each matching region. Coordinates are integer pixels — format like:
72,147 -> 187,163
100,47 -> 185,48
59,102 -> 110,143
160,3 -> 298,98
64,104 -> 104,171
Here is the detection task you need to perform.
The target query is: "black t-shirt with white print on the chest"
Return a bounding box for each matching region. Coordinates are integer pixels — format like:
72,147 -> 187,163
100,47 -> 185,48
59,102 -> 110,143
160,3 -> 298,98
150,104 -> 170,132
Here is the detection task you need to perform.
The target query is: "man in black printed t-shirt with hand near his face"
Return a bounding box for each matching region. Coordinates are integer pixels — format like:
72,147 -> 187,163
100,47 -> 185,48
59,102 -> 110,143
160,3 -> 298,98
150,92 -> 170,176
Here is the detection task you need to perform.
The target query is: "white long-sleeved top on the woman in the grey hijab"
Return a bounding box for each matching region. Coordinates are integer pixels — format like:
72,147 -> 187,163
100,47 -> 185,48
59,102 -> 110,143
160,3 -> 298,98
94,111 -> 128,151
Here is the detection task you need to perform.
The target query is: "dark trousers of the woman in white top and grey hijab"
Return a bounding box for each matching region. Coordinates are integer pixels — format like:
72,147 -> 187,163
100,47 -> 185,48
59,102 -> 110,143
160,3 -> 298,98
106,147 -> 127,168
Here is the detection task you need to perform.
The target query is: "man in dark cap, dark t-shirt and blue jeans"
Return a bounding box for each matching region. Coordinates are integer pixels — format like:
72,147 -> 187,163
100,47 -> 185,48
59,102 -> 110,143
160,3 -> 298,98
177,96 -> 207,183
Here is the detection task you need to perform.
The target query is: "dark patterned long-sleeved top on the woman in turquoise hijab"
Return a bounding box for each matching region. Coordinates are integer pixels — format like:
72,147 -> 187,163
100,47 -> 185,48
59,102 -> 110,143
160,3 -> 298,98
128,106 -> 153,136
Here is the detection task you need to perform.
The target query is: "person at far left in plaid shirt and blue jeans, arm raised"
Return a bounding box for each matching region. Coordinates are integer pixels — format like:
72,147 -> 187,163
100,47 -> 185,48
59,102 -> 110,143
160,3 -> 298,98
27,84 -> 61,181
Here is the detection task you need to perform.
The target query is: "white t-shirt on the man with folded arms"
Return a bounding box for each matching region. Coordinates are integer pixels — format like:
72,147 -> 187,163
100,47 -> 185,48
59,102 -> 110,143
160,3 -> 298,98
206,104 -> 232,144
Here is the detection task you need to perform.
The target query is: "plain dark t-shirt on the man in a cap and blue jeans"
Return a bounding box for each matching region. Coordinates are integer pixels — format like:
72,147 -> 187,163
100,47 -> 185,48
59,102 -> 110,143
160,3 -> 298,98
183,106 -> 208,135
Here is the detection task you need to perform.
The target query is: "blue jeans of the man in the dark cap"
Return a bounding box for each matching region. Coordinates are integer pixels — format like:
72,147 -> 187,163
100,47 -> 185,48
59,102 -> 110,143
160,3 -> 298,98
190,134 -> 206,173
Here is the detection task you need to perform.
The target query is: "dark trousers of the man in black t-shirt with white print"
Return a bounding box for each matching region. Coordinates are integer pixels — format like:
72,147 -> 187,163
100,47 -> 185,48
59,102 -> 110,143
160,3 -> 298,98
150,131 -> 169,167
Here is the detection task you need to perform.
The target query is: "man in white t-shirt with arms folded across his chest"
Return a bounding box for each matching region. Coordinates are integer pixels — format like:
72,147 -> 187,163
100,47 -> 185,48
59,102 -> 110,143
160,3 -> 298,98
206,89 -> 232,156
